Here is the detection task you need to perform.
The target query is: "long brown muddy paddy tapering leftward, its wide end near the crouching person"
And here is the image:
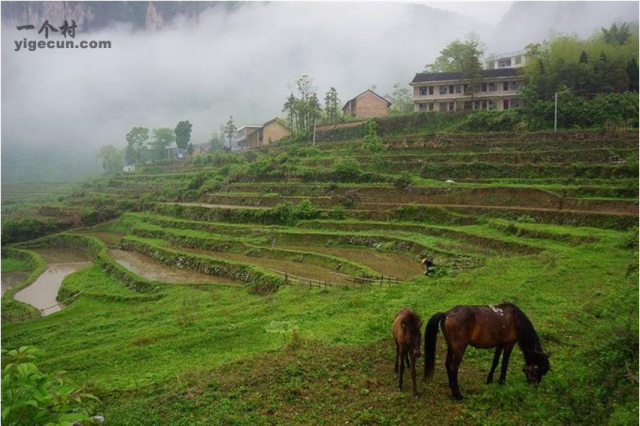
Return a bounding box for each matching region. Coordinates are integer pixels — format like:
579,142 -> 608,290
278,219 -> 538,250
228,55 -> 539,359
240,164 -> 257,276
280,246 -> 424,280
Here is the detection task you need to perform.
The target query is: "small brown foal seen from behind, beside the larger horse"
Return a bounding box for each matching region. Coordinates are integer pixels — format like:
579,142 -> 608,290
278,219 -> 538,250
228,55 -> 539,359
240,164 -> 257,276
391,308 -> 422,398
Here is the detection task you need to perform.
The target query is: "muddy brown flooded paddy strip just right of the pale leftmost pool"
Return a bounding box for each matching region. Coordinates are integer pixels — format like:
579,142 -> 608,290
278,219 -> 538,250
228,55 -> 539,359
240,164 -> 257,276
107,250 -> 244,286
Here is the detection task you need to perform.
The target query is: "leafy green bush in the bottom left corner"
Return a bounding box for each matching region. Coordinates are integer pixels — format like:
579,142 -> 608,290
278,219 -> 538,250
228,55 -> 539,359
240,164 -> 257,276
2,346 -> 97,425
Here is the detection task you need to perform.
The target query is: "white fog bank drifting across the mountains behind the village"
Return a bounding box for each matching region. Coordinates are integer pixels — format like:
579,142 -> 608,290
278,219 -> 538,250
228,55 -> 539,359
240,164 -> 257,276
2,3 -> 638,166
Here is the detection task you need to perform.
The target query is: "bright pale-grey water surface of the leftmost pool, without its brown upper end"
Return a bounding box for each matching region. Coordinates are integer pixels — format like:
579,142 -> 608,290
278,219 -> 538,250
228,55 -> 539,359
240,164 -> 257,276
15,262 -> 91,315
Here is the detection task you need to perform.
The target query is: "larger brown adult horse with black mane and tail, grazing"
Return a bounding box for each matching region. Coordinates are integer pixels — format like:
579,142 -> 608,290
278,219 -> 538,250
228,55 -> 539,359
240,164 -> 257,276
424,303 -> 550,399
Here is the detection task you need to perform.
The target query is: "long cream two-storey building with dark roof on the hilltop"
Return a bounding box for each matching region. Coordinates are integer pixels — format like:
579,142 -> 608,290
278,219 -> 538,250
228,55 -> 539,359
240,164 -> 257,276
410,68 -> 525,111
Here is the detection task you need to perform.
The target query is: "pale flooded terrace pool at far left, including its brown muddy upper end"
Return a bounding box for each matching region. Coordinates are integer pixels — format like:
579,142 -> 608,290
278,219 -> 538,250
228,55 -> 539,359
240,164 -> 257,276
15,248 -> 90,315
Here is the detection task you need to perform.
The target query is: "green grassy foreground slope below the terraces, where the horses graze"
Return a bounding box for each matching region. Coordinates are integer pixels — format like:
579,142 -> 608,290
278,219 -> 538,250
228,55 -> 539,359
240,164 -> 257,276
2,225 -> 638,424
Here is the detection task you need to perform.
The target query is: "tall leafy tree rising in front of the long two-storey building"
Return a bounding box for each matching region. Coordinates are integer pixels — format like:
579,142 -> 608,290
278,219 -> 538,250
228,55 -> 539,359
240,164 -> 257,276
425,33 -> 484,107
